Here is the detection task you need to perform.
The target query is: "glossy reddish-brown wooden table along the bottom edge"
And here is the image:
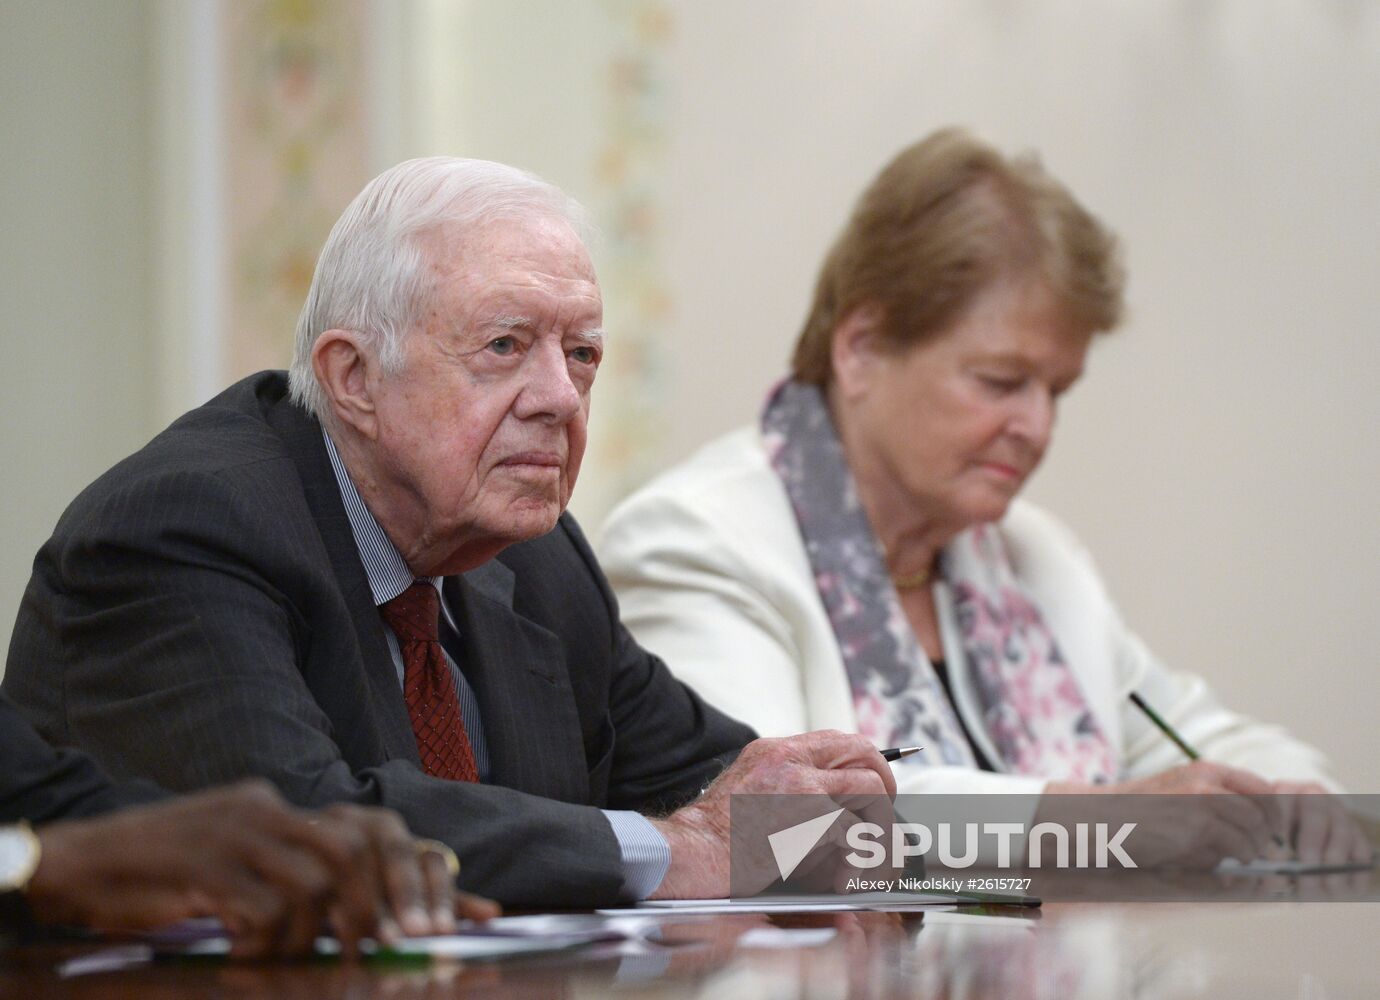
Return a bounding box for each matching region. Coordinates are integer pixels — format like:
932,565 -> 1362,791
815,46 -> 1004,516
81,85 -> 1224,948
0,902 -> 1380,1000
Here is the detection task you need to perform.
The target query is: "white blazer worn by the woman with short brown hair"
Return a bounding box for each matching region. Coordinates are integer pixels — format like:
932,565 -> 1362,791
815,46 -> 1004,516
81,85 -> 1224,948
598,426 -> 1337,793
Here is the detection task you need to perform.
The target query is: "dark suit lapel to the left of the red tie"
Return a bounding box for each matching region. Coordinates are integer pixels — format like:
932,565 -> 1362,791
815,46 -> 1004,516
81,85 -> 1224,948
269,388 -> 421,767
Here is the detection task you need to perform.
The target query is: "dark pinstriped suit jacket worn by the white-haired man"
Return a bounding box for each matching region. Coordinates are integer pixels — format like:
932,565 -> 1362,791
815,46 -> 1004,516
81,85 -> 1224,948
4,372 -> 752,906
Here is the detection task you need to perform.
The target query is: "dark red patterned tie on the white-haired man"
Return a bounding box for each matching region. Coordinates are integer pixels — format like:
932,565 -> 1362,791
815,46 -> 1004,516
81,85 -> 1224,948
378,581 -> 479,781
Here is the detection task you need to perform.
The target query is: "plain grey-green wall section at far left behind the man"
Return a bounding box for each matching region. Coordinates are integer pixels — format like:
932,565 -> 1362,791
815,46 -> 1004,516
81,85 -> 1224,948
0,0 -> 155,669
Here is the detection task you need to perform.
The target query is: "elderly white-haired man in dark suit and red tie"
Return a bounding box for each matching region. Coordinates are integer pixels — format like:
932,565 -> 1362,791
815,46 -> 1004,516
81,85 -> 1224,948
4,159 -> 894,906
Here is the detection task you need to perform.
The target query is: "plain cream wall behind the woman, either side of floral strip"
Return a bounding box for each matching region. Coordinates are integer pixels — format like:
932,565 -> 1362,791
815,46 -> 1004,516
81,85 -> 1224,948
419,0 -> 1380,789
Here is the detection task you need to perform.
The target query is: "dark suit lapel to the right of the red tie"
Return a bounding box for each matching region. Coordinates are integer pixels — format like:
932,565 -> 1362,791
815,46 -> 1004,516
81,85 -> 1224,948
444,573 -> 589,803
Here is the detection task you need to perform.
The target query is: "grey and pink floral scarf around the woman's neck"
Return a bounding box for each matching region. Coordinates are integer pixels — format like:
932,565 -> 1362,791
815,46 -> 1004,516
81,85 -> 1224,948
762,381 -> 1116,782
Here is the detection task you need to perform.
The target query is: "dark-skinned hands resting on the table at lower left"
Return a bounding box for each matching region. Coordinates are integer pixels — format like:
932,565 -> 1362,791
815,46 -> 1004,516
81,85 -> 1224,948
28,782 -> 498,956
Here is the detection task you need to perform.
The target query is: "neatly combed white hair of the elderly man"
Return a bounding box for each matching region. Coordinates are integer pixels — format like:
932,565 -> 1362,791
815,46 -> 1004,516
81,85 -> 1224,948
287,156 -> 591,422
